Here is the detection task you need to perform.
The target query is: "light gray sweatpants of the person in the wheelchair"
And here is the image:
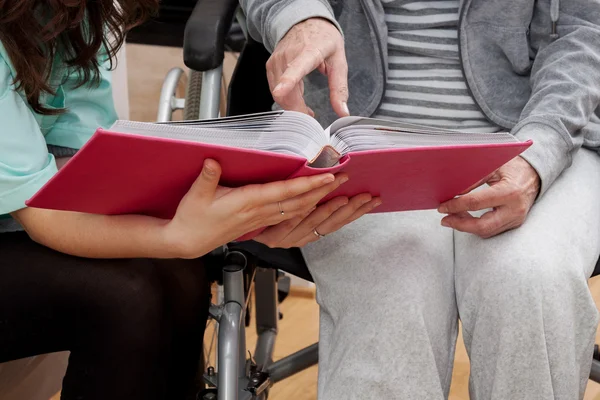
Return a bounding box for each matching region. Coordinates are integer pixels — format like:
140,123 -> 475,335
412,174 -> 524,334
304,150 -> 600,400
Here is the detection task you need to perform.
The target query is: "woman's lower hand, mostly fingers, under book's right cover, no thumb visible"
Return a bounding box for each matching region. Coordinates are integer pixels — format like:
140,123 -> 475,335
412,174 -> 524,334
254,193 -> 381,248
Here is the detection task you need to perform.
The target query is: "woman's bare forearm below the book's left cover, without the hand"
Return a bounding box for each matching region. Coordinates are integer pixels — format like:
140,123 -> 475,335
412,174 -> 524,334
12,208 -> 192,258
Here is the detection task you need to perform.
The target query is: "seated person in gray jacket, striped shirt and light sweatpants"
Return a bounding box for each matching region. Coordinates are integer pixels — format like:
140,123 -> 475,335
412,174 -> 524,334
242,0 -> 600,400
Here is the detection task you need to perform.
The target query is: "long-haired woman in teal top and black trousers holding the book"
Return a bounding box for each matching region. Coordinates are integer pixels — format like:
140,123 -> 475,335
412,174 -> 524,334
0,0 -> 378,400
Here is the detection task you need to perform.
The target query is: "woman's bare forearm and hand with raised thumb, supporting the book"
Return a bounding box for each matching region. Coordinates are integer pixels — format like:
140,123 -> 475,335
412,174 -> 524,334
11,160 -> 346,258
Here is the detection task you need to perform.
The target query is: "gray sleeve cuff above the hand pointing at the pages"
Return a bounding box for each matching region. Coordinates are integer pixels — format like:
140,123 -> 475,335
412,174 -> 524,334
264,0 -> 343,53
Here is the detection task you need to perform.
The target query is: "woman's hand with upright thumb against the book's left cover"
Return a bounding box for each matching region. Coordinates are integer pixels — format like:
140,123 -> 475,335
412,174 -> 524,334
164,160 -> 347,258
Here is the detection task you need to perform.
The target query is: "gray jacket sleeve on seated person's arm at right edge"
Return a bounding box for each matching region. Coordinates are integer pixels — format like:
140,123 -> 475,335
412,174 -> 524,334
513,4 -> 600,195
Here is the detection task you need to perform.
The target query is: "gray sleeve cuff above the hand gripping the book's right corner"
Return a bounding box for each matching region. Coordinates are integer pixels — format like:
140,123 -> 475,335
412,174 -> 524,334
513,122 -> 572,199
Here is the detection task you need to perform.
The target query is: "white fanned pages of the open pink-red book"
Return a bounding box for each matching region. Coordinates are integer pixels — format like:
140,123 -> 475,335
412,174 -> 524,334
110,111 -> 518,168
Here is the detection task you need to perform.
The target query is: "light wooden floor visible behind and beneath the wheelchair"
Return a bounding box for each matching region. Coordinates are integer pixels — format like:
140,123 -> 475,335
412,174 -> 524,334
53,45 -> 600,400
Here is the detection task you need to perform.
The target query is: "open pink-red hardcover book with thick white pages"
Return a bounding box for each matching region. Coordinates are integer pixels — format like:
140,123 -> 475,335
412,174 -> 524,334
28,111 -> 531,218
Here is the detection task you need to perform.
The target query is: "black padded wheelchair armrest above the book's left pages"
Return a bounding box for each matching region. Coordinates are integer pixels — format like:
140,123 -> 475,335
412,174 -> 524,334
183,0 -> 239,71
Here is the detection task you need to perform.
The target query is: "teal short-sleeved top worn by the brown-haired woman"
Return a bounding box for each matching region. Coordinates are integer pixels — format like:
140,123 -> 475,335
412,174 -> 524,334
0,42 -> 117,231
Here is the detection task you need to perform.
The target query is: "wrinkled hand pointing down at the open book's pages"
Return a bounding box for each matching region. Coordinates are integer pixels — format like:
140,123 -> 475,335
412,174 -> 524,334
267,18 -> 350,117
